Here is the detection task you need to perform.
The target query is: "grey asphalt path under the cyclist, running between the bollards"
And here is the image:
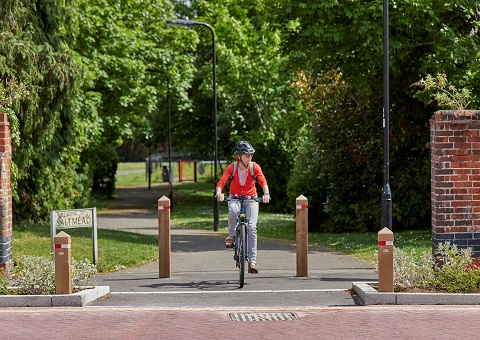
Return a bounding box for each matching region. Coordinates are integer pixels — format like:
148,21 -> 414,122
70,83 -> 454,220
91,188 -> 377,308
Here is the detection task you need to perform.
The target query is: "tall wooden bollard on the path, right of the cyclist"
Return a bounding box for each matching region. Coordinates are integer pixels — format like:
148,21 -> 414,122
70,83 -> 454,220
296,195 -> 308,276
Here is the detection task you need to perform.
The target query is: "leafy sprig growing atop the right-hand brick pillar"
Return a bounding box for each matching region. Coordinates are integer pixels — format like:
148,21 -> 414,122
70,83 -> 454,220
413,73 -> 471,110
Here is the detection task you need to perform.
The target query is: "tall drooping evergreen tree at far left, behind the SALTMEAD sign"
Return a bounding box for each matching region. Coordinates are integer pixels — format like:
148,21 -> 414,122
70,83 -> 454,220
0,0 -> 93,220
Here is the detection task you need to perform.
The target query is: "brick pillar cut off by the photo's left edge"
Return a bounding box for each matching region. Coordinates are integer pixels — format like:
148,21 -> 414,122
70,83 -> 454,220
0,112 -> 12,272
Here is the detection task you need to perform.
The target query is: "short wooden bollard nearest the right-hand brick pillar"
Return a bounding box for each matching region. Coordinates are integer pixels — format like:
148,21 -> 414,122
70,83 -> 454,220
378,228 -> 393,292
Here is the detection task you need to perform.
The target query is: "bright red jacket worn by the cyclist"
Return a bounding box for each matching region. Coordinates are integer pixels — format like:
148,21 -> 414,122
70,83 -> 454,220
217,162 -> 267,197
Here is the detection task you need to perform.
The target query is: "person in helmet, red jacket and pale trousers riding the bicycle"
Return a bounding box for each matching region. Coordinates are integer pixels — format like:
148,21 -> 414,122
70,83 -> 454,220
216,141 -> 270,274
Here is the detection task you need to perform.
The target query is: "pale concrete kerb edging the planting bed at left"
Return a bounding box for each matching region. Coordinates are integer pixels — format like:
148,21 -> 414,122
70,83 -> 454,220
0,286 -> 110,307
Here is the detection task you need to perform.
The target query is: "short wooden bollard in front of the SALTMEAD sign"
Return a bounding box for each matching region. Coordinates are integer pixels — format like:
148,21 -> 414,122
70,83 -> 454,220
53,231 -> 72,294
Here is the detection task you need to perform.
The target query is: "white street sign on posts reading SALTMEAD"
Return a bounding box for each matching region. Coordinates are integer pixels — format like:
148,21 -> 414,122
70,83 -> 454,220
50,208 -> 98,264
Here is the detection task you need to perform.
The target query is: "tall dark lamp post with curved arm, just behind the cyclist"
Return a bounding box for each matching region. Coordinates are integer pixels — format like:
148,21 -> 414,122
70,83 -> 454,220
167,19 -> 220,231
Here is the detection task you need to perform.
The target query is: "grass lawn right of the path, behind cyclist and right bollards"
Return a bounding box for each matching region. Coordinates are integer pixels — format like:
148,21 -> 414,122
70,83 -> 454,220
163,179 -> 432,261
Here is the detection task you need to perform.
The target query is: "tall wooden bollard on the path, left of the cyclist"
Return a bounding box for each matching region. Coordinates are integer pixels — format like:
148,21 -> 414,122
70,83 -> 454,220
158,196 -> 172,279
